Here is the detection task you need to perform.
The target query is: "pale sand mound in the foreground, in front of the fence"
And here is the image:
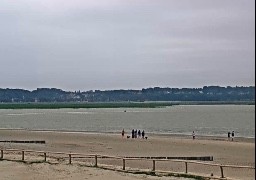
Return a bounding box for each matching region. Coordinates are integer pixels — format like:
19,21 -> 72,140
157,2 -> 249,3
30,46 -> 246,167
0,161 -> 189,180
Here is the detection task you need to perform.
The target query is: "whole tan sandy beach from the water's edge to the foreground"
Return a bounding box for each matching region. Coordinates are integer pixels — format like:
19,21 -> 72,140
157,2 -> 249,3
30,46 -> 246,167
0,129 -> 255,180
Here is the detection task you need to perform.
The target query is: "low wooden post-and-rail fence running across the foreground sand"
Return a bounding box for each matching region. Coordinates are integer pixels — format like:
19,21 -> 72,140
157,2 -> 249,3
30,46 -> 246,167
0,149 -> 255,179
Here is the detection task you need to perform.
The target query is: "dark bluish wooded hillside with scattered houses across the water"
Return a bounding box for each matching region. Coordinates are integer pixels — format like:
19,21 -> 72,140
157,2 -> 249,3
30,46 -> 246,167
0,86 -> 255,103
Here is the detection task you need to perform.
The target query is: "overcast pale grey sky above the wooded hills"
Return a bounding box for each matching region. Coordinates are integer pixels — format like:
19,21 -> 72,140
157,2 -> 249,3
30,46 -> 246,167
0,0 -> 255,91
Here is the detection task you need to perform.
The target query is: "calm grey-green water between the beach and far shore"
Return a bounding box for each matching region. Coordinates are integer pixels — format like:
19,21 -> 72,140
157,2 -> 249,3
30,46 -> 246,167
0,105 -> 255,137
